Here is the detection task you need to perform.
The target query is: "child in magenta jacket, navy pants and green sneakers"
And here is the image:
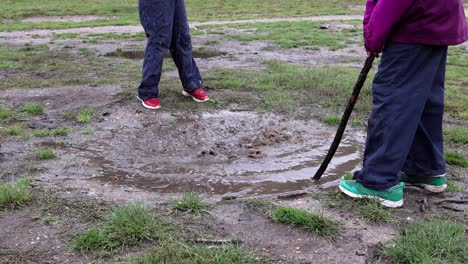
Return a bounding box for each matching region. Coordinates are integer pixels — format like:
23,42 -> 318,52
339,0 -> 468,207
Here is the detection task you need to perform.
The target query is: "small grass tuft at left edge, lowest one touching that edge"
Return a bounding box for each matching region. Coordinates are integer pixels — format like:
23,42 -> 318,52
0,178 -> 33,208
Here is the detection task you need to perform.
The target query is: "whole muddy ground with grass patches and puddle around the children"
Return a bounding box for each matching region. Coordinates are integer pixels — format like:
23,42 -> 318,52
0,0 -> 468,263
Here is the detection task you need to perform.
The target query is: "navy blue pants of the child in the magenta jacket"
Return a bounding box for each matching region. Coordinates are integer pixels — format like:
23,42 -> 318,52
354,42 -> 447,190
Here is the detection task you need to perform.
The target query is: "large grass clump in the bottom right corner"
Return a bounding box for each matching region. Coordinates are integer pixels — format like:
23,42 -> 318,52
383,220 -> 468,264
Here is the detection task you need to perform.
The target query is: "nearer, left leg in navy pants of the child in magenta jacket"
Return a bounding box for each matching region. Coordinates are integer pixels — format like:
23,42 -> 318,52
355,43 -> 445,190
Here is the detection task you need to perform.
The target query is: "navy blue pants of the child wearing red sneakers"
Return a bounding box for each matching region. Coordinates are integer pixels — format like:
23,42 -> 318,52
138,0 -> 202,100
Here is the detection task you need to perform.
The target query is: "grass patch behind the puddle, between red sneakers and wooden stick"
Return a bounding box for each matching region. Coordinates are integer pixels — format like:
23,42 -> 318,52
205,61 -> 372,114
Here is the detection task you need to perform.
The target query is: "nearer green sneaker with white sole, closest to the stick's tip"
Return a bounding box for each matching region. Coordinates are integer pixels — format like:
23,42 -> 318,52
339,180 -> 405,208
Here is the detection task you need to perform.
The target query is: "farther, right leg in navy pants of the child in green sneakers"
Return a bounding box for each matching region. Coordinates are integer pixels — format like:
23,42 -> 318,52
402,47 -> 447,178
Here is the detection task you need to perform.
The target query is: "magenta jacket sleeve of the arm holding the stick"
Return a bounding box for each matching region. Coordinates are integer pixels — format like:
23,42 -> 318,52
364,0 -> 414,52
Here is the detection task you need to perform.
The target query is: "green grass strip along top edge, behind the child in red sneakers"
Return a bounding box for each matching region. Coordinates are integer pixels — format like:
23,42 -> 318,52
0,0 -> 362,31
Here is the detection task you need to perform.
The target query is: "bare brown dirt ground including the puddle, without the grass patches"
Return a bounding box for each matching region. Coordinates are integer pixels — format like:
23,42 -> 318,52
0,12 -> 468,263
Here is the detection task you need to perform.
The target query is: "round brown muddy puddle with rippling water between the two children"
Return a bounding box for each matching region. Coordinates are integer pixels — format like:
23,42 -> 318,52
44,111 -> 365,196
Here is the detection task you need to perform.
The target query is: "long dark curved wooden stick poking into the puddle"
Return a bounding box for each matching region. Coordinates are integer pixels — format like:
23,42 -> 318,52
313,55 -> 375,181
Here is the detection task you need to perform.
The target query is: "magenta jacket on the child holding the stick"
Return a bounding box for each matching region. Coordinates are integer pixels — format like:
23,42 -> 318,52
364,0 -> 468,52
